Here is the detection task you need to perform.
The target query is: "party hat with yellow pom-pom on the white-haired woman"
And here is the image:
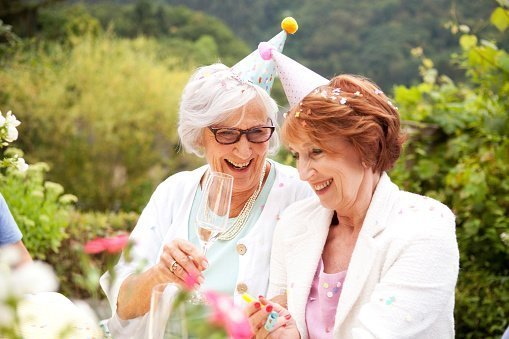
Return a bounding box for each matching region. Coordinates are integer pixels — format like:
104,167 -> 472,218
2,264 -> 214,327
231,17 -> 299,94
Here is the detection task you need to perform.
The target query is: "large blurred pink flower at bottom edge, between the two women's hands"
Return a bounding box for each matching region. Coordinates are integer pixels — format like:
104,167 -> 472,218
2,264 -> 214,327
205,291 -> 253,339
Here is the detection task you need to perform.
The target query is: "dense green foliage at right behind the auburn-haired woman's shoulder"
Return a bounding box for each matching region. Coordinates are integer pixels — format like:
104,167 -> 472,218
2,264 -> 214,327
391,5 -> 509,338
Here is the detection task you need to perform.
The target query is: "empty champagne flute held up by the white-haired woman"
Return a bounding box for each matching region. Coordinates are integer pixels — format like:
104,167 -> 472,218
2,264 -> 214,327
191,172 -> 233,304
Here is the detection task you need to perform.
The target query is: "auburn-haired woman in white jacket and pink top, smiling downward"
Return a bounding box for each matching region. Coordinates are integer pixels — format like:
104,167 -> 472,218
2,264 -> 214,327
246,75 -> 459,338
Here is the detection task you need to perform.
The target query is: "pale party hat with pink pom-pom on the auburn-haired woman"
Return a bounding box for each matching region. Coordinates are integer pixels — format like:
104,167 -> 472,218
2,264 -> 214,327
258,42 -> 329,107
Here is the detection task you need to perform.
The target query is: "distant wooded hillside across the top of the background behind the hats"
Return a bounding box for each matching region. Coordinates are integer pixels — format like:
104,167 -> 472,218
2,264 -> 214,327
0,0 -> 509,91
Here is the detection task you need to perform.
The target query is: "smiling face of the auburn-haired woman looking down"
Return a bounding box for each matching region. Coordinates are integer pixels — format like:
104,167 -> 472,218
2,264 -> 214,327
289,139 -> 373,215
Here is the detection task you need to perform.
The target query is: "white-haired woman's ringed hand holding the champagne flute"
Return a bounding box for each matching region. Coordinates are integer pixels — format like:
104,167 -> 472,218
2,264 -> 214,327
154,239 -> 208,289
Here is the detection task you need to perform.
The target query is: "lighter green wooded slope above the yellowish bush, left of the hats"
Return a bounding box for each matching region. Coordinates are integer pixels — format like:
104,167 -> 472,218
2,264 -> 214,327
84,0 -> 249,65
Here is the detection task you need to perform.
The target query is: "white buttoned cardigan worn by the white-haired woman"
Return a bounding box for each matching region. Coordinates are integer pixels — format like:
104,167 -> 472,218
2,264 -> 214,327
101,160 -> 313,338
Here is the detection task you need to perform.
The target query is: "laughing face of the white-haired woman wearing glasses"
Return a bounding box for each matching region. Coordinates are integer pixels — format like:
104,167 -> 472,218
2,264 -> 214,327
203,100 -> 270,193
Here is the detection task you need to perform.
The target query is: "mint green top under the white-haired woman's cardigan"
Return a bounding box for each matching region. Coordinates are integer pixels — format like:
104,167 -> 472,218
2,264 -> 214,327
188,161 -> 276,294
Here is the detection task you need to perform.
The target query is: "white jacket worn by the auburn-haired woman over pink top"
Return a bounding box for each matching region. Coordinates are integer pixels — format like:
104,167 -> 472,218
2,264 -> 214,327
268,173 -> 459,339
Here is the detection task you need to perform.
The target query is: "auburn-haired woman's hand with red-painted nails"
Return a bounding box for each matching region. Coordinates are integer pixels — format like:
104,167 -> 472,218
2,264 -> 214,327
244,296 -> 300,339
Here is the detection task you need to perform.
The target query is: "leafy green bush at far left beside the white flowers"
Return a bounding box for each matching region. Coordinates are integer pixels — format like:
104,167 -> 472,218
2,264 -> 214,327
0,130 -> 138,298
